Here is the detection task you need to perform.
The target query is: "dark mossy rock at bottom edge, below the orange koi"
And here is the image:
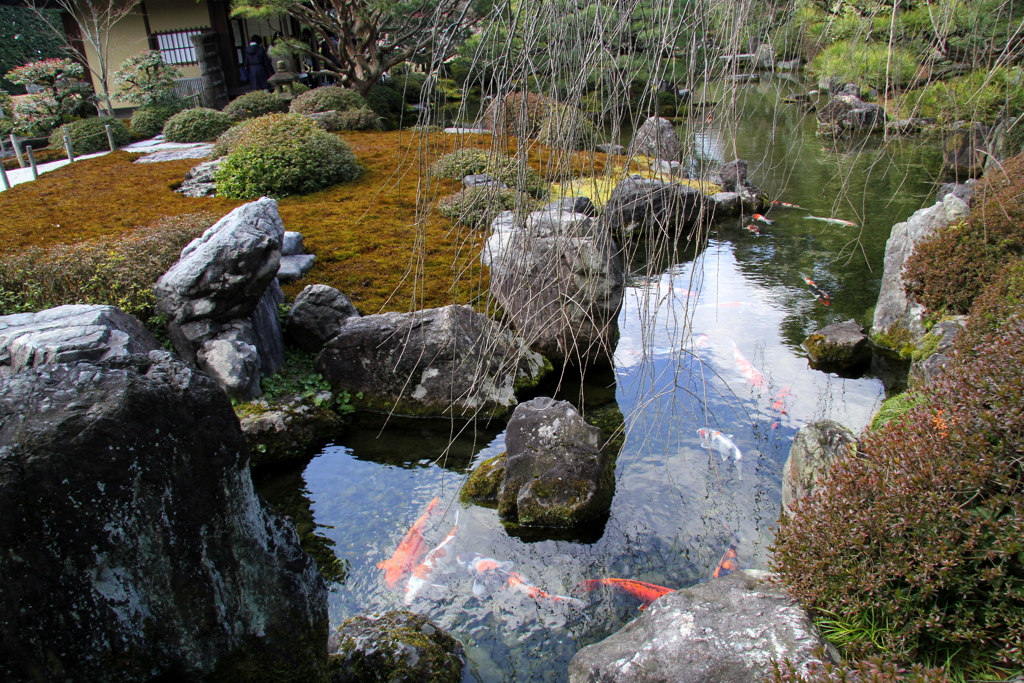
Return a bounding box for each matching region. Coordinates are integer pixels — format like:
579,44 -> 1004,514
329,611 -> 466,683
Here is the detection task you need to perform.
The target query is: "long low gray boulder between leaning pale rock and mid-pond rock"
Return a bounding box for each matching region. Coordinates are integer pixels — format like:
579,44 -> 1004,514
315,306 -> 551,418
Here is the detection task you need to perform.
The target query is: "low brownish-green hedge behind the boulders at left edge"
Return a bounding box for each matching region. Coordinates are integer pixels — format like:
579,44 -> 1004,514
0,212 -> 216,323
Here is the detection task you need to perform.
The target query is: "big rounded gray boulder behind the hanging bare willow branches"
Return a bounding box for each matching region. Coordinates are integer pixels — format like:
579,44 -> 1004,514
490,211 -> 625,365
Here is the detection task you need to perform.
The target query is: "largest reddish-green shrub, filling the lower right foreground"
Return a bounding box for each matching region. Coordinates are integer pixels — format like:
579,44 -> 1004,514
772,317 -> 1024,680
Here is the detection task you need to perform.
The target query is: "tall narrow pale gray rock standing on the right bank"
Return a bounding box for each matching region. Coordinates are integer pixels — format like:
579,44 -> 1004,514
871,194 -> 970,350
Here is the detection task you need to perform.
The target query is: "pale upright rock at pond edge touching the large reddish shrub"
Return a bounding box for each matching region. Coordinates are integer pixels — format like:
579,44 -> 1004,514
782,420 -> 857,517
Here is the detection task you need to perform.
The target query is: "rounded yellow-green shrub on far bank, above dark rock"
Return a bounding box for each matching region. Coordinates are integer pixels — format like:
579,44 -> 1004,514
807,39 -> 920,92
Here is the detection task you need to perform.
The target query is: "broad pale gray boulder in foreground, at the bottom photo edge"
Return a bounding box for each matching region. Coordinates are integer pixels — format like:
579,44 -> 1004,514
569,569 -> 824,683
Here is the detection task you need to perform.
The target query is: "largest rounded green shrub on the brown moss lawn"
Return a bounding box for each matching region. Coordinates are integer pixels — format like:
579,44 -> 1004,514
214,114 -> 362,200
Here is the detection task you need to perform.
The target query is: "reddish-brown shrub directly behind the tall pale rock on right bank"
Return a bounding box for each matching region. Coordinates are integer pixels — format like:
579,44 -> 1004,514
903,155 -> 1024,313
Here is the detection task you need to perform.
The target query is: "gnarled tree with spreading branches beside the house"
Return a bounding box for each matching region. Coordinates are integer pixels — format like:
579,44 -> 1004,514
232,0 -> 489,94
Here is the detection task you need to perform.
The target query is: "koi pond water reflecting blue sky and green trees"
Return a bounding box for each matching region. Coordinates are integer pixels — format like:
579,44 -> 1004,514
256,72 -> 939,683
